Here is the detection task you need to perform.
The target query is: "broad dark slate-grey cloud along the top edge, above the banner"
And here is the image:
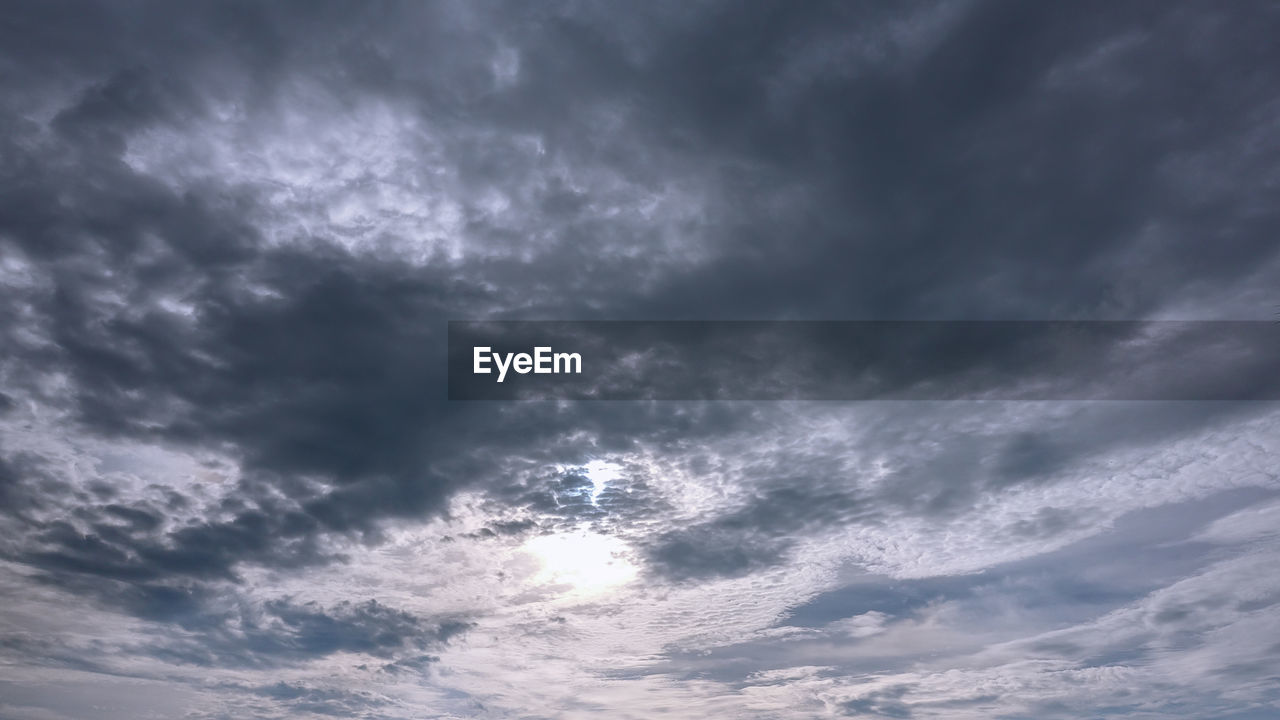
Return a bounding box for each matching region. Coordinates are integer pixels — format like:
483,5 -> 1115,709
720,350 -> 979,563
12,3 -> 1275,318
